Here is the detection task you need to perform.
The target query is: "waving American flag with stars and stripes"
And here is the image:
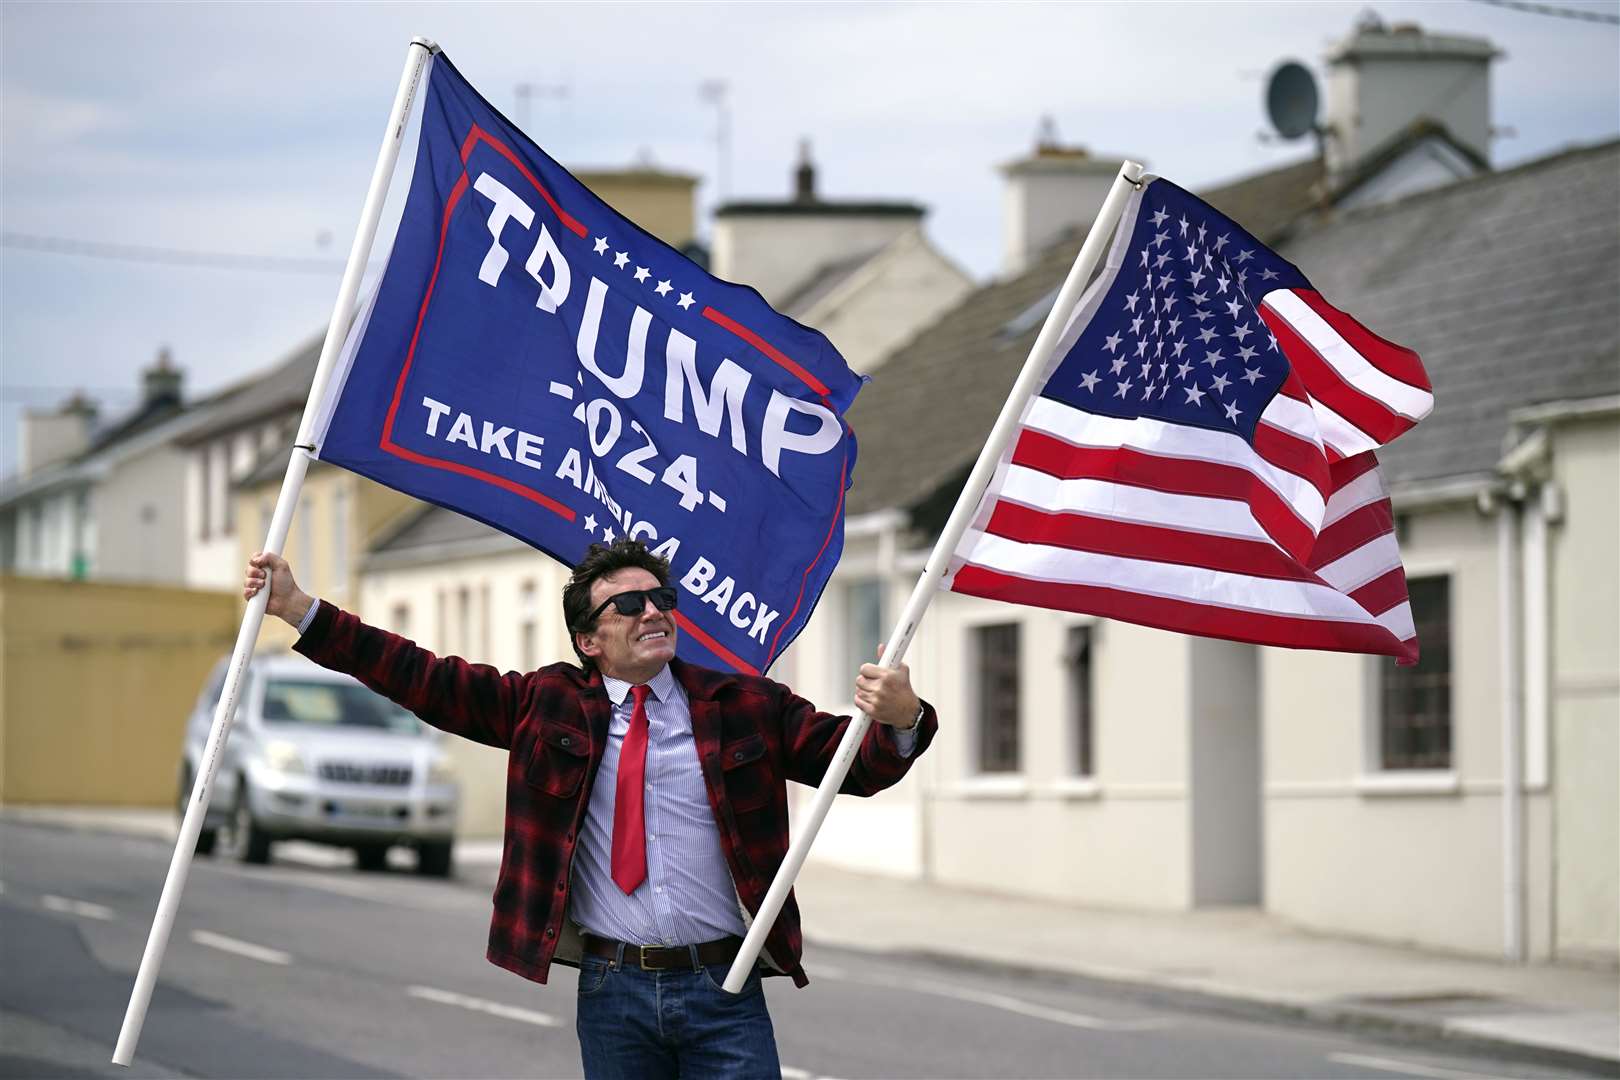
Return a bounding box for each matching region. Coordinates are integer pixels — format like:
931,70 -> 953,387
944,178 -> 1434,662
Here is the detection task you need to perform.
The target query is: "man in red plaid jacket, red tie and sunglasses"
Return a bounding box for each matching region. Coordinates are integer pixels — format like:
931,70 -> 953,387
243,539 -> 936,1080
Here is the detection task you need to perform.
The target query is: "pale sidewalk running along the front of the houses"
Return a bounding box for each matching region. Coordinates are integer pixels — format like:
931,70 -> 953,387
12,806 -> 1620,1075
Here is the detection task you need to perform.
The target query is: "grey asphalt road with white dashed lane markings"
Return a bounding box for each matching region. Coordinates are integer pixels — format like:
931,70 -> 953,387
0,823 -> 1581,1080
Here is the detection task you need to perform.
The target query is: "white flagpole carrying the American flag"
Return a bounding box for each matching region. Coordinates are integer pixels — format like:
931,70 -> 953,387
726,162 -> 1142,994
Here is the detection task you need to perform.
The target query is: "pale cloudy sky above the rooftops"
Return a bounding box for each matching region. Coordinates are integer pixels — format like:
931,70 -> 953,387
0,0 -> 1620,476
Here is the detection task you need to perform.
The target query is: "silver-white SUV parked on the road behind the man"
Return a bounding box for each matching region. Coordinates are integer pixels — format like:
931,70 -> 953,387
178,653 -> 460,878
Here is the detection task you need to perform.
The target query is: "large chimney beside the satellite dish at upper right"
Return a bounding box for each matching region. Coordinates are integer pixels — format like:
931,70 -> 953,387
1327,13 -> 1502,175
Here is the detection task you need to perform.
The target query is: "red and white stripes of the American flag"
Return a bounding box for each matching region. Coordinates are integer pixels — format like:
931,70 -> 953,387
946,290 -> 1434,661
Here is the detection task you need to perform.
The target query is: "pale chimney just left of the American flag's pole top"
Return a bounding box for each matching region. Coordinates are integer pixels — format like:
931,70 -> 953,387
1001,117 -> 1123,277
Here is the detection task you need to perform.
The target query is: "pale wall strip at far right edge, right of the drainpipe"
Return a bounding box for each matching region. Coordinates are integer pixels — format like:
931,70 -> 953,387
1549,415 -> 1620,963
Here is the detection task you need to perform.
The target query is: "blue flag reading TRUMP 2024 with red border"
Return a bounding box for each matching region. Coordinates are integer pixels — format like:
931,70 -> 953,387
316,55 -> 860,672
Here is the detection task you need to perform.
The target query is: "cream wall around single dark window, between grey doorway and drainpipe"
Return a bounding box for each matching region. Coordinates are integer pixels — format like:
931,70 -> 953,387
1260,502 -> 1549,954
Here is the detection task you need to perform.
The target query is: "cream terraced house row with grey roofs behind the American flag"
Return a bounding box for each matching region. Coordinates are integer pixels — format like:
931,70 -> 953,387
777,24 -> 1620,962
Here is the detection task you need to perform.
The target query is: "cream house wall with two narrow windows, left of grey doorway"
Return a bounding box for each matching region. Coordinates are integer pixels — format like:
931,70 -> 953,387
928,593 -> 1191,910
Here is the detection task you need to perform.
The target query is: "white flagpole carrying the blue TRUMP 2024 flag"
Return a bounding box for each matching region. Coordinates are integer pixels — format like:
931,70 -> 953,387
112,37 -> 439,1065
